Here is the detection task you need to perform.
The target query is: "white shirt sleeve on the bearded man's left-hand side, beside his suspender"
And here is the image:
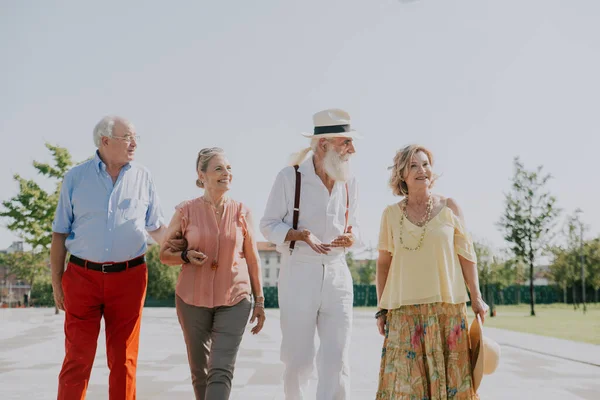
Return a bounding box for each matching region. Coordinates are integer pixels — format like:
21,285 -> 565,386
260,170 -> 292,245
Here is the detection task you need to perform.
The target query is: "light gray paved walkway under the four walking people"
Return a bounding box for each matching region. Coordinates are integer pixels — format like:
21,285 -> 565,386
0,308 -> 600,400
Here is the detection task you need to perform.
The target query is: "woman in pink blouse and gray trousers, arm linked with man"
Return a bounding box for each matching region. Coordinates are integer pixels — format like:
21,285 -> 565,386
160,148 -> 265,400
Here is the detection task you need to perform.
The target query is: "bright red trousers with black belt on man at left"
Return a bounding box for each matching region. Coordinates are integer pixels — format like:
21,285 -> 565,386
58,263 -> 148,400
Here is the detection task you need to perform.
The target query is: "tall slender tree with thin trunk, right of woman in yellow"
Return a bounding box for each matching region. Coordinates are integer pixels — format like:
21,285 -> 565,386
498,157 -> 560,316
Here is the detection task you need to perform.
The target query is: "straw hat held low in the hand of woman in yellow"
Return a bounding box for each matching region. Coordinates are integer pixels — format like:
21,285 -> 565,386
469,314 -> 500,391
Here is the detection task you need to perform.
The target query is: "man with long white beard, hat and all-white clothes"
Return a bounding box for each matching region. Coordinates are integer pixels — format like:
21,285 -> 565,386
260,109 -> 362,400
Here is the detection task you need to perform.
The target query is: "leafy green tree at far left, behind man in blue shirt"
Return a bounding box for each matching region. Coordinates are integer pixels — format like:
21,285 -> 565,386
0,143 -> 73,310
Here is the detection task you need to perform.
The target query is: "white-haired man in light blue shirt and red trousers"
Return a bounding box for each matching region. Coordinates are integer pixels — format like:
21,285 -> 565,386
50,117 -> 184,400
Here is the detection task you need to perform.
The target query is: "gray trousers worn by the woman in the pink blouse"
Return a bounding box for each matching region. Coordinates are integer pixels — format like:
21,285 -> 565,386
176,296 -> 252,400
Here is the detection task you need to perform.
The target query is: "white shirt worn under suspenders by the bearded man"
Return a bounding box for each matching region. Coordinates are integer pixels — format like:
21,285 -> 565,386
260,157 -> 363,257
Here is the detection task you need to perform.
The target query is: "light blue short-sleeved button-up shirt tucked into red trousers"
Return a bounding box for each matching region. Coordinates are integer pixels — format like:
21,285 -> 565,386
52,152 -> 164,263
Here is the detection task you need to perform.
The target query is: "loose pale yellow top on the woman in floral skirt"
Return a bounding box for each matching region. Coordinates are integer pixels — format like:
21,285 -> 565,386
378,204 -> 477,310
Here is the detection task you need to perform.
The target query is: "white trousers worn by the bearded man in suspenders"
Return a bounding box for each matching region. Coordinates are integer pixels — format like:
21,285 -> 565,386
278,254 -> 354,400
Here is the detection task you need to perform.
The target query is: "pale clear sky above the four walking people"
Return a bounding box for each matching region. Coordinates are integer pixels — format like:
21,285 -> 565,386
0,0 -> 600,258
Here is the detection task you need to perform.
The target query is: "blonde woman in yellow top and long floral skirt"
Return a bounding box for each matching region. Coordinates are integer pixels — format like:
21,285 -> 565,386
376,145 -> 488,400
